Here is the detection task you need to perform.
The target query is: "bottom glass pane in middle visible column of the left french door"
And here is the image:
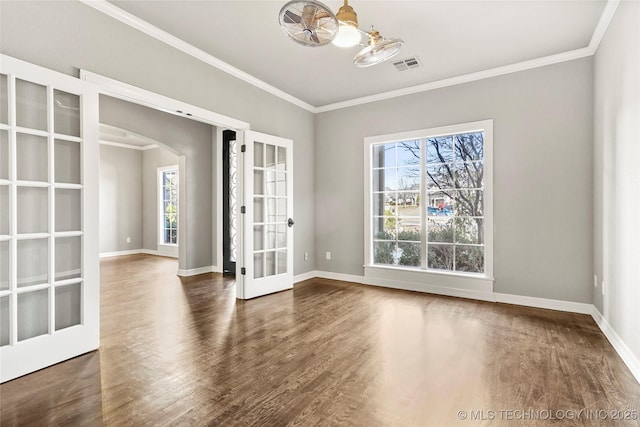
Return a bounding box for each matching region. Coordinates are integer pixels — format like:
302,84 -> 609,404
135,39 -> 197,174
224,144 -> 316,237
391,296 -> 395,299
18,289 -> 49,341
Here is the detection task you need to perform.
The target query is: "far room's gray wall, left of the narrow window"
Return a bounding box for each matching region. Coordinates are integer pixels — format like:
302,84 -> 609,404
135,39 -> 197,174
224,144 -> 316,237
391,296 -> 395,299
100,145 -> 142,253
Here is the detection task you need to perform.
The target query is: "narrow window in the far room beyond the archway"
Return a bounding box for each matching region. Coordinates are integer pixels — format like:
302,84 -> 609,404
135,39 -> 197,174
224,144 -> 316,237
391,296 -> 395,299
158,166 -> 178,245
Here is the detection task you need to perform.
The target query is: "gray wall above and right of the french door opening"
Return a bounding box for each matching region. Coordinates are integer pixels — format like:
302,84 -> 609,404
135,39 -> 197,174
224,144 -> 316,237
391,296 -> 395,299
0,1 -> 315,274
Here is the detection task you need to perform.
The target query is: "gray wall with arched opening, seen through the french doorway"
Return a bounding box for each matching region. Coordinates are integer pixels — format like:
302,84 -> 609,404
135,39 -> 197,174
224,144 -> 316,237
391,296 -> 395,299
100,96 -> 211,269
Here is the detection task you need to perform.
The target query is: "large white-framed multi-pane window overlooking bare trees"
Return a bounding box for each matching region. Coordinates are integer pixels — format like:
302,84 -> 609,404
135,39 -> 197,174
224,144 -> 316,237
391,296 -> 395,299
365,120 -> 493,277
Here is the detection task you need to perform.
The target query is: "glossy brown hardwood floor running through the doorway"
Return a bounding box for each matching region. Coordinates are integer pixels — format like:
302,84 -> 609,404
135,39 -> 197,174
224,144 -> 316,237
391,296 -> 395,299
0,255 -> 640,427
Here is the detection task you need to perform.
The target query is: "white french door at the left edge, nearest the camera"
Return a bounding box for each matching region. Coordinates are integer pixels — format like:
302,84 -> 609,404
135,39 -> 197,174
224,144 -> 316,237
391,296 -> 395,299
0,55 -> 100,382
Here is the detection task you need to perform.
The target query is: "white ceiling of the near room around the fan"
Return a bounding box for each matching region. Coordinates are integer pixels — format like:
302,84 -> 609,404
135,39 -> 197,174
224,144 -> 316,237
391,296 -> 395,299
111,0 -> 607,107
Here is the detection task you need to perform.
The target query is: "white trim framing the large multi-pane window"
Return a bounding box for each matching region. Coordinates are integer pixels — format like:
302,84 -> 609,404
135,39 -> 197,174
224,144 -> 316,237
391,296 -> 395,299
364,119 -> 493,281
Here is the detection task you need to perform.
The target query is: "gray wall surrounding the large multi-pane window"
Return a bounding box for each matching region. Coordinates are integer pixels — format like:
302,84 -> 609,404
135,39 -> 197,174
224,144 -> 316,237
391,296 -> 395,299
314,58 -> 593,303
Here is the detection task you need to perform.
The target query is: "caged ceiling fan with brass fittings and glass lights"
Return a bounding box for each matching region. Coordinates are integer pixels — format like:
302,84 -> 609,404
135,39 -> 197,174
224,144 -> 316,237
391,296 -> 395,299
279,0 -> 404,67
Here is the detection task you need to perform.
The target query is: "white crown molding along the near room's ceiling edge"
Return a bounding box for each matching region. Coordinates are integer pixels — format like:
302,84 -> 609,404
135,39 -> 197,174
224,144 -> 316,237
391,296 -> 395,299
79,0 -> 620,114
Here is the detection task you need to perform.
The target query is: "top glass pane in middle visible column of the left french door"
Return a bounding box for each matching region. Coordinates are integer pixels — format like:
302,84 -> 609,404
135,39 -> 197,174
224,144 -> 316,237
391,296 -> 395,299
16,79 -> 47,131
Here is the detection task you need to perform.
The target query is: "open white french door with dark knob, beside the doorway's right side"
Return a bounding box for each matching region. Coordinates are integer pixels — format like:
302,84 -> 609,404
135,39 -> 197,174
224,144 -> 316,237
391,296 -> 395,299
236,131 -> 293,299
